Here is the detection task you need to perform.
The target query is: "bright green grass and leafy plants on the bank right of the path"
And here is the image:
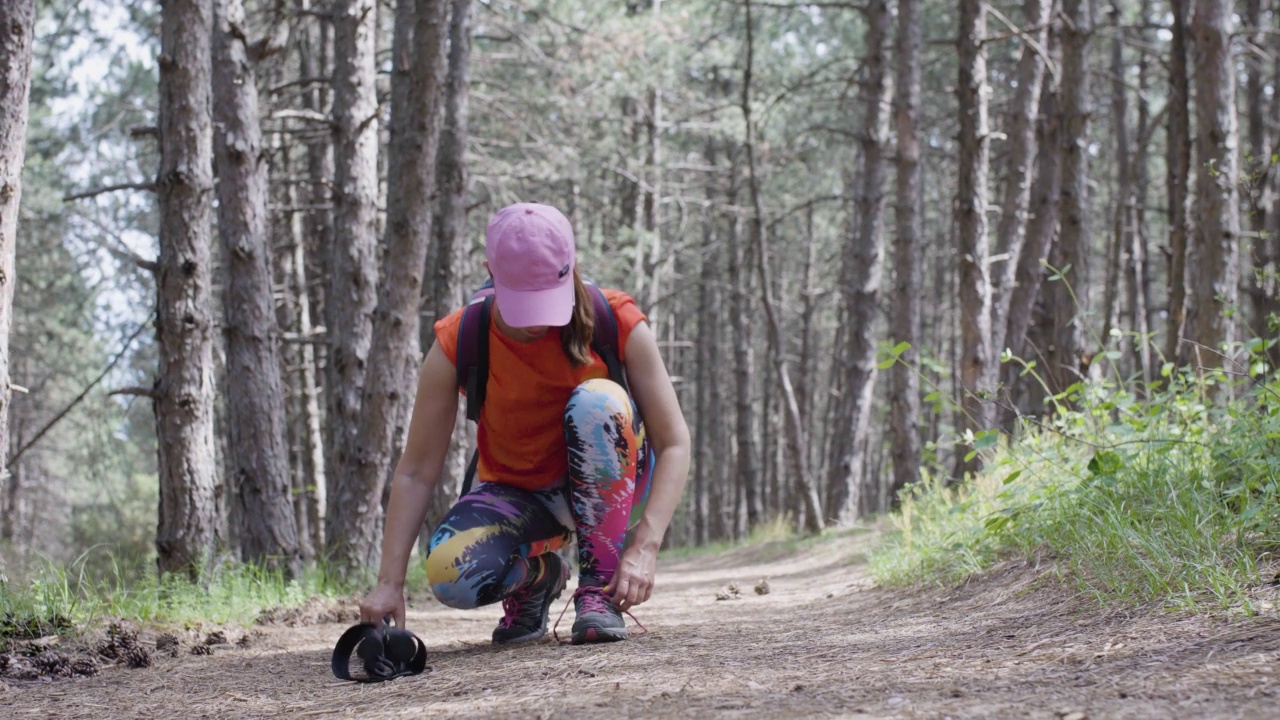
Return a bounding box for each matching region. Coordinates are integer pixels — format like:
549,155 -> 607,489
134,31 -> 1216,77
870,363 -> 1280,612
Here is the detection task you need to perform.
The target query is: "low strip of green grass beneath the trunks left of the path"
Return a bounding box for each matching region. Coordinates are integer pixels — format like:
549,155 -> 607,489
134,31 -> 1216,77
0,548 -> 342,639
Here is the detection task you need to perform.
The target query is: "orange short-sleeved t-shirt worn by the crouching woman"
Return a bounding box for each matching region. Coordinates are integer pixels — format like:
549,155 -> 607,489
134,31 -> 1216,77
435,288 -> 646,489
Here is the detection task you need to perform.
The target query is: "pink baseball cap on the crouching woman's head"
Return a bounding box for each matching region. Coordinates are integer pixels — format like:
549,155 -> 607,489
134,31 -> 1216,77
484,202 -> 577,328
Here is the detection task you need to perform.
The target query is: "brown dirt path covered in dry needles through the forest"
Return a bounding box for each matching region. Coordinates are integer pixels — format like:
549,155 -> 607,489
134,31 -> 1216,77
0,536 -> 1280,720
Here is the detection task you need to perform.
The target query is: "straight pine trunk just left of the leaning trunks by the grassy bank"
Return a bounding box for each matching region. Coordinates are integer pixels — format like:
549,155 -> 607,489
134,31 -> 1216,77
956,0 -> 995,477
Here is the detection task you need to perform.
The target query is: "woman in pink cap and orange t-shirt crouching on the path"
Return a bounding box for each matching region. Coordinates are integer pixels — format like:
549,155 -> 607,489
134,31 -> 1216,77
360,204 -> 690,644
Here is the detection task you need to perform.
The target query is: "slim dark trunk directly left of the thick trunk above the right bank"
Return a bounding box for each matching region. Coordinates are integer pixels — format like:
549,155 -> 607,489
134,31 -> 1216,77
1165,0 -> 1192,364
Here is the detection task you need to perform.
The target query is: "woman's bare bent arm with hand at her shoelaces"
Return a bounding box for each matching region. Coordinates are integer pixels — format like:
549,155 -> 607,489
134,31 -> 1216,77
608,323 -> 691,610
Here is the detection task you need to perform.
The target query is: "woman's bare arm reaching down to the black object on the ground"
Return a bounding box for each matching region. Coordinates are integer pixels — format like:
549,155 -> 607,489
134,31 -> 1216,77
360,343 -> 458,628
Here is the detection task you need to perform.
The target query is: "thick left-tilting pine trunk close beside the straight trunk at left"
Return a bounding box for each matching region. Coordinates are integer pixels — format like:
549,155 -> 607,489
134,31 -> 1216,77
212,0 -> 301,575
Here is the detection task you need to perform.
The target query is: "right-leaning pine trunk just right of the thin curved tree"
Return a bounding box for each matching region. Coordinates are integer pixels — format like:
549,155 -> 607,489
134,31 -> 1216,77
827,0 -> 892,515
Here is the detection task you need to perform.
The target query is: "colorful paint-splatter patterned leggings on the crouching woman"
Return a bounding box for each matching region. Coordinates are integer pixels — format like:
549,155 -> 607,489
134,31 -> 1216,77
426,379 -> 653,607
